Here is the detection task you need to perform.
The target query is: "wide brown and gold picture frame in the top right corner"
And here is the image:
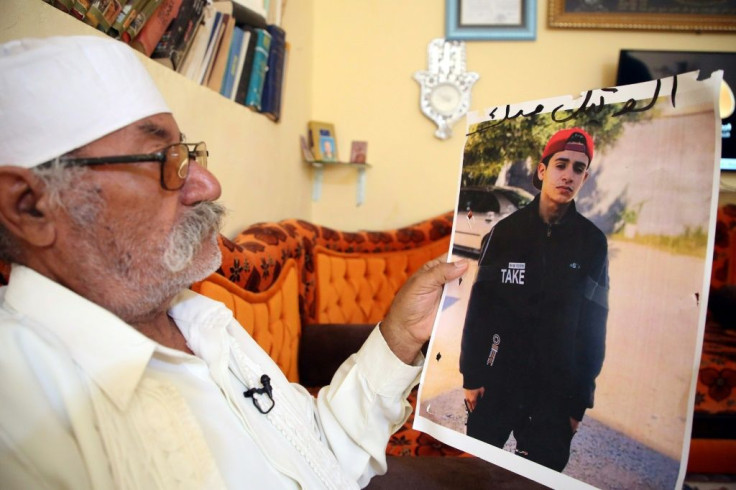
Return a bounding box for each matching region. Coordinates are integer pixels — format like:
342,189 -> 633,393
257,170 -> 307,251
548,0 -> 736,32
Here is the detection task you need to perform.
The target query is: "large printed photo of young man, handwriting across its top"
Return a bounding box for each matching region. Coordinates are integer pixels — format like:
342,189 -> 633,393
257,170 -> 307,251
413,72 -> 720,490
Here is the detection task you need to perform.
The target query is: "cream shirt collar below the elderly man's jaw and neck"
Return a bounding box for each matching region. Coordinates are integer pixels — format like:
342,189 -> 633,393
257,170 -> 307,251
5,264 -> 160,410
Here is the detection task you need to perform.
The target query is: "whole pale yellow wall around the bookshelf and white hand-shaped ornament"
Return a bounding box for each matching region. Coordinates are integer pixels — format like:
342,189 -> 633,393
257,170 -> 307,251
0,0 -> 736,236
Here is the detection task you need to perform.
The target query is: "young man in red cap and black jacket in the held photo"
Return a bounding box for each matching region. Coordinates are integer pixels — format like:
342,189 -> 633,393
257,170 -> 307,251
460,128 -> 608,471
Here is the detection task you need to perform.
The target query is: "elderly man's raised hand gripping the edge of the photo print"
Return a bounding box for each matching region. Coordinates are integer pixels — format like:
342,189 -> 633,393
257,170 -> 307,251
381,255 -> 468,364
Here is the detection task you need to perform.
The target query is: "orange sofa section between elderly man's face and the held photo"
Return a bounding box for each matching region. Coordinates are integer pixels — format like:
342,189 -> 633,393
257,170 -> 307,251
187,213 -> 453,386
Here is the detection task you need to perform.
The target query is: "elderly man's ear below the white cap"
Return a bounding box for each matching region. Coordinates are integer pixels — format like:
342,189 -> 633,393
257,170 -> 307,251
0,166 -> 56,247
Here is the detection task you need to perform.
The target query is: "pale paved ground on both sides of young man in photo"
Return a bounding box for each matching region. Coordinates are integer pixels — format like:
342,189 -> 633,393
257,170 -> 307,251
414,241 -> 703,489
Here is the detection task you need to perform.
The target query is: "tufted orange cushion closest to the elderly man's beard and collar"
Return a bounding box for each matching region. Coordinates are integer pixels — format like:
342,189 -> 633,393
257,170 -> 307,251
192,259 -> 301,383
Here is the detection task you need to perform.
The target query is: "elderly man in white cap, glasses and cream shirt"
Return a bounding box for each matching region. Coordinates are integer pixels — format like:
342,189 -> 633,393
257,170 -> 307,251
0,37 -> 466,489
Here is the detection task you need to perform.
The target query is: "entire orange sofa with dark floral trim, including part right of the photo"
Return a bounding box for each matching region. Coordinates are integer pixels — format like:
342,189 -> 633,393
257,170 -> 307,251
0,205 -> 736,473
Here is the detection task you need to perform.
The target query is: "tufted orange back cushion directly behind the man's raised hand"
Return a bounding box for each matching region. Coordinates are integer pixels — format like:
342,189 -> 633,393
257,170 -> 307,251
314,235 -> 450,324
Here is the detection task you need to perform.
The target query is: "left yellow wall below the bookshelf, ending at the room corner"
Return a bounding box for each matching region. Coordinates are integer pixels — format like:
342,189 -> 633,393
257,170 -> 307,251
0,0 -> 313,236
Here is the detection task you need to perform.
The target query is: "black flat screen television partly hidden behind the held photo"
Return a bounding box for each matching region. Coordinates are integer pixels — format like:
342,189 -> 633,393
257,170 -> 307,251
616,49 -> 736,171
